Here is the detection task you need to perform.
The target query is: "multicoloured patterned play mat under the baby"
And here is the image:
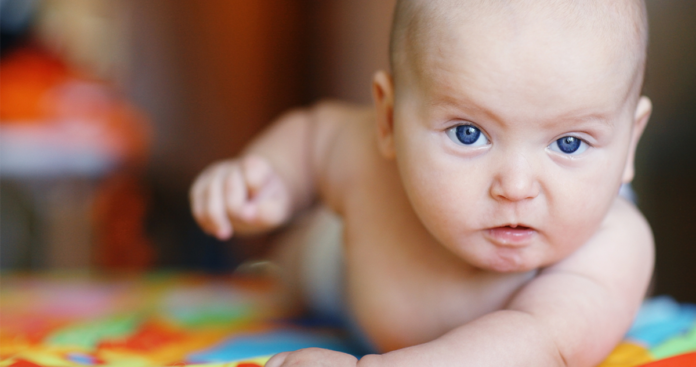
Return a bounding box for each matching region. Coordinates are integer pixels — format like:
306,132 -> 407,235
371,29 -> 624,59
0,273 -> 696,367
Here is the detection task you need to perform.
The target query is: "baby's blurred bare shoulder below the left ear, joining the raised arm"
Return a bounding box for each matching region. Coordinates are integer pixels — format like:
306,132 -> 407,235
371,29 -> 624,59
310,100 -> 374,213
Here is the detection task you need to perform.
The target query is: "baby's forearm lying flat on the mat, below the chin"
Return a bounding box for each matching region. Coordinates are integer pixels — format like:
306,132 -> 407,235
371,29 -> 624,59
358,310 -> 568,367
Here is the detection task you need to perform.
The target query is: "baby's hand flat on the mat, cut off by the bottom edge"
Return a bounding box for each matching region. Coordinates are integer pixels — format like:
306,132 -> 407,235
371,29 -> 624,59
265,348 -> 358,367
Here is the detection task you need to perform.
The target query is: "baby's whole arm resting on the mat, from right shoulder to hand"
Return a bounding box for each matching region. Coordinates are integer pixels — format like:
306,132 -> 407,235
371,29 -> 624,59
267,199 -> 653,367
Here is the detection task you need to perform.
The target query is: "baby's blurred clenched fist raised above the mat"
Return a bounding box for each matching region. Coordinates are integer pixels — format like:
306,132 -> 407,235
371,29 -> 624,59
190,155 -> 291,240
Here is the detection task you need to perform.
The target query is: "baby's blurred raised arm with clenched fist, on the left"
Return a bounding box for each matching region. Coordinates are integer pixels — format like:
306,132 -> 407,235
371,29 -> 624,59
190,103 -> 348,239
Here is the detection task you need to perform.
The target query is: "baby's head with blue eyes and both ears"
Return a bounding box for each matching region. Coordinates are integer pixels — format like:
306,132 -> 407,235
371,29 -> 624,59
373,0 -> 651,271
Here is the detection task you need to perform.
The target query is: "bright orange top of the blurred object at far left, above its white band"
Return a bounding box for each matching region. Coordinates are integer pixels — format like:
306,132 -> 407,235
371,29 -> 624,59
0,47 -> 150,165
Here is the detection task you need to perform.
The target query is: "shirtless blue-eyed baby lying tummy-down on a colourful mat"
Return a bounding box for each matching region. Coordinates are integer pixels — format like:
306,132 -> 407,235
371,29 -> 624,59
191,0 -> 653,367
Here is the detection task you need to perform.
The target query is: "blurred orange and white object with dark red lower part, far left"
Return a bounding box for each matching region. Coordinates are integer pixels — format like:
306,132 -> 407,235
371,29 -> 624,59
0,46 -> 154,269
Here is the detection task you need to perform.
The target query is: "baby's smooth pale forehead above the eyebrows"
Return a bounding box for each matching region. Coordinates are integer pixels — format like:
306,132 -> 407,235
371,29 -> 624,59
402,3 -> 638,120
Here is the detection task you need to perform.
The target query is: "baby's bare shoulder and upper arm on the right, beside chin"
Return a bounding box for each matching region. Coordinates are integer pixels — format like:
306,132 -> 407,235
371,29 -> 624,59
508,198 -> 654,365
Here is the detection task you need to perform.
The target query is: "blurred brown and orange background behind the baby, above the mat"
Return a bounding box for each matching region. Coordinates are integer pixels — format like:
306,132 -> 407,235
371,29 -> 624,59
0,0 -> 696,302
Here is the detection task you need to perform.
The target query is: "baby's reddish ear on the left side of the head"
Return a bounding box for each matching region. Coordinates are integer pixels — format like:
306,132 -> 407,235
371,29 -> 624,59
372,71 -> 395,159
